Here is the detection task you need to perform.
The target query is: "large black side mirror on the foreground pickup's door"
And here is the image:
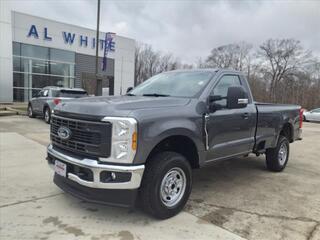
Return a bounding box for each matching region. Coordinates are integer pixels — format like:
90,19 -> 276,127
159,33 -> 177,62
227,87 -> 249,109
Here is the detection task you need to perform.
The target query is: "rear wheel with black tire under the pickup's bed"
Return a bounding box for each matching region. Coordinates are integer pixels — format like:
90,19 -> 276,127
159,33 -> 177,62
266,136 -> 290,172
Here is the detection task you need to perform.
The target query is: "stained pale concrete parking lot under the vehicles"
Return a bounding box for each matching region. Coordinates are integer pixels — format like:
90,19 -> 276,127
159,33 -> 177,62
0,116 -> 320,240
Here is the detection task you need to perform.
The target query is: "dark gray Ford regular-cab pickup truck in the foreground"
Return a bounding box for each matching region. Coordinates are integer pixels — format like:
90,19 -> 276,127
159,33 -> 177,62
47,69 -> 303,219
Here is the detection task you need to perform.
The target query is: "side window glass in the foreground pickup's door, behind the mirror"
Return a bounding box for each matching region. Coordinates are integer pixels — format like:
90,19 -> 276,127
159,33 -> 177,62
211,75 -> 241,107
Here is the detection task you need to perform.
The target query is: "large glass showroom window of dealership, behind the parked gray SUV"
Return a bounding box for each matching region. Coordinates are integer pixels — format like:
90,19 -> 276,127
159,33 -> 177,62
13,42 -> 75,102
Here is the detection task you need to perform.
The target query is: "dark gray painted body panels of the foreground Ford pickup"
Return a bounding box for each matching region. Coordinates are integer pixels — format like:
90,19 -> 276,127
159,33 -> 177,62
56,70 -> 300,166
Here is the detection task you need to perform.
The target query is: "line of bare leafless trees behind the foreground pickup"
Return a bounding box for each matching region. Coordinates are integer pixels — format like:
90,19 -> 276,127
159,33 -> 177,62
135,39 -> 320,109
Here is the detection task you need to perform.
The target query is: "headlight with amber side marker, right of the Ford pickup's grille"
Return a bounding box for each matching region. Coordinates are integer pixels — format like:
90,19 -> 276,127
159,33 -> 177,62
99,117 -> 137,163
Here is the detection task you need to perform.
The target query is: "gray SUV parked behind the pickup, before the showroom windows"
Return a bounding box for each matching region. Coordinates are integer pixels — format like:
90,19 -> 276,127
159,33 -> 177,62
28,86 -> 88,123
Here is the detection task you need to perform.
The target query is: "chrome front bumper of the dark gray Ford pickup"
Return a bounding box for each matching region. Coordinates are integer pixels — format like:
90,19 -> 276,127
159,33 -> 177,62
47,144 -> 144,189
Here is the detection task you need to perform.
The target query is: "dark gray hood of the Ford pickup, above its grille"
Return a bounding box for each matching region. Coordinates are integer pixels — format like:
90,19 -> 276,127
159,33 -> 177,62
55,96 -> 190,117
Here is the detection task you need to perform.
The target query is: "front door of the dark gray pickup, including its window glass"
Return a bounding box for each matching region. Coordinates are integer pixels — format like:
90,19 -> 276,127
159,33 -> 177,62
207,74 -> 256,161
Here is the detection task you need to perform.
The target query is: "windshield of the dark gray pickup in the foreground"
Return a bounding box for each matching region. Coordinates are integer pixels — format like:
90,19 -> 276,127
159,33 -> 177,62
128,71 -> 213,97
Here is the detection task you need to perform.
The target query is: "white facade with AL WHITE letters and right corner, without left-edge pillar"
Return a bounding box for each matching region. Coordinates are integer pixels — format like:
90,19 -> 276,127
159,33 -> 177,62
12,12 -> 135,95
